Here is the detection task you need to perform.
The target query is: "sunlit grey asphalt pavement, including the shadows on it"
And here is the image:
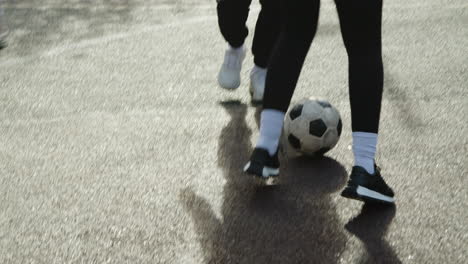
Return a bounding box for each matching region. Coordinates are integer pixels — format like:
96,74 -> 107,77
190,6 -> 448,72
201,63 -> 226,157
0,0 -> 468,264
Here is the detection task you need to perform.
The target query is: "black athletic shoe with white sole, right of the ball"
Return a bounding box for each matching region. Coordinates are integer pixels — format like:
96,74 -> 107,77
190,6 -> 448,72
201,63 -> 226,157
341,166 -> 395,203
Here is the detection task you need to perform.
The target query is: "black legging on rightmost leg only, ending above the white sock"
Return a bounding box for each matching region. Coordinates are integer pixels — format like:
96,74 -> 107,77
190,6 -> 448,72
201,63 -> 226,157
336,0 -> 383,136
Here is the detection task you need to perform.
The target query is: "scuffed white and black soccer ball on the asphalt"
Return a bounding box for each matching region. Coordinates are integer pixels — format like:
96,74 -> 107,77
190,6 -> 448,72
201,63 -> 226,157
283,98 -> 343,156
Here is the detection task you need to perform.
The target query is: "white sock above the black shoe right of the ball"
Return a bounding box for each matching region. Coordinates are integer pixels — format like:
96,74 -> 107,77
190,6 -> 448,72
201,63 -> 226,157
353,132 -> 377,174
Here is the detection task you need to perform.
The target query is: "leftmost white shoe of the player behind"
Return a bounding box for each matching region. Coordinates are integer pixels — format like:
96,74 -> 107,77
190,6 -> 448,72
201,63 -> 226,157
218,46 -> 247,90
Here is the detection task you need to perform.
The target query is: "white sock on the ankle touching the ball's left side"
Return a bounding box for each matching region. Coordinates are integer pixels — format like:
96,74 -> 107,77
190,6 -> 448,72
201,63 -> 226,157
256,109 -> 285,156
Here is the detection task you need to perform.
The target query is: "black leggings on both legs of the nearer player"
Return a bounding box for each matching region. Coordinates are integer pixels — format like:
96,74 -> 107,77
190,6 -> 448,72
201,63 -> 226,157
264,0 -> 383,133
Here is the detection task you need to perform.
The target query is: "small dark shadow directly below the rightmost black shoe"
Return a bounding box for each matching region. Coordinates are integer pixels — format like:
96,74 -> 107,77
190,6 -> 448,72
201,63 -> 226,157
345,204 -> 401,264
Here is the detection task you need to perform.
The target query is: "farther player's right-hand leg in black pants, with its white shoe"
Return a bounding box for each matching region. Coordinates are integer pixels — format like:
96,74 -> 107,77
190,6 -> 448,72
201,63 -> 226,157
250,0 -> 284,104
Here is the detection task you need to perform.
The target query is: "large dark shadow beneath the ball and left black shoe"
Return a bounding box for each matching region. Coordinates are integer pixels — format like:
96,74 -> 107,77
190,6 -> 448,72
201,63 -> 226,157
180,101 -> 346,263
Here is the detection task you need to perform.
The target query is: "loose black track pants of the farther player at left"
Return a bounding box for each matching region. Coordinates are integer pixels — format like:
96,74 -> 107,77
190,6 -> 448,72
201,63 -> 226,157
217,0 -> 281,68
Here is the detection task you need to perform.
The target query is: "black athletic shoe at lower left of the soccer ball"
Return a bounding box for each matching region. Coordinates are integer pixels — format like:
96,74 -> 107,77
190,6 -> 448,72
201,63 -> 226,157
244,148 -> 279,179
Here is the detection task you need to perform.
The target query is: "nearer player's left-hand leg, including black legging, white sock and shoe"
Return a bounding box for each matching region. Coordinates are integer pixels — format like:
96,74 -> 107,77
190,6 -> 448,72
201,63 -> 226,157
244,0 -> 320,177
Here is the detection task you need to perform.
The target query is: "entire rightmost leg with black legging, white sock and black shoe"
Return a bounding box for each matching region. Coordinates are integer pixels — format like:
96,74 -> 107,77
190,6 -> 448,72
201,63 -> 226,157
335,0 -> 394,202
